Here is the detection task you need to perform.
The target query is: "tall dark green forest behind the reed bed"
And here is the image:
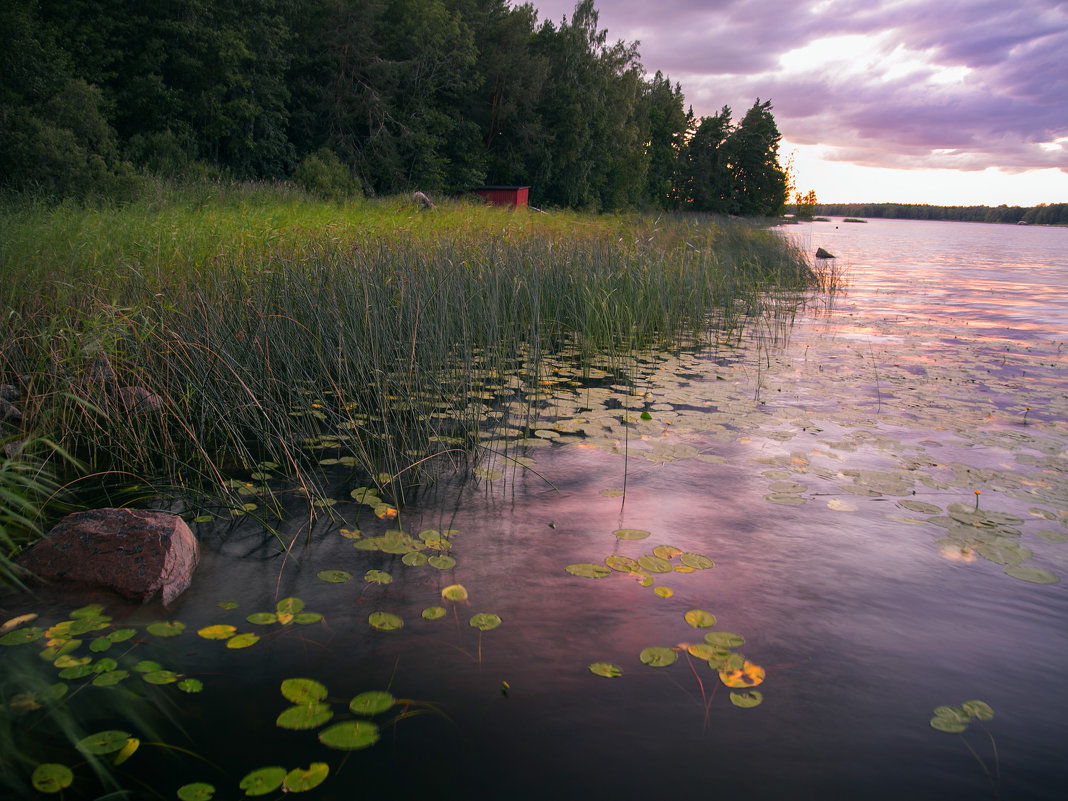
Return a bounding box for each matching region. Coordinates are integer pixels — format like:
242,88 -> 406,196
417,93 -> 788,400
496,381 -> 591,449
0,0 -> 786,215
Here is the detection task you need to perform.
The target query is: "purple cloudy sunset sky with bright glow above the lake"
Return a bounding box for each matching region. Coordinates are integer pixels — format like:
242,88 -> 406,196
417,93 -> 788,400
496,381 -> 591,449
531,0 -> 1068,206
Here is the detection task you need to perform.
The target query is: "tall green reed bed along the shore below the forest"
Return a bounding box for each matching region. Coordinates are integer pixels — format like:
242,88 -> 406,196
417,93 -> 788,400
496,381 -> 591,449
0,184 -> 836,585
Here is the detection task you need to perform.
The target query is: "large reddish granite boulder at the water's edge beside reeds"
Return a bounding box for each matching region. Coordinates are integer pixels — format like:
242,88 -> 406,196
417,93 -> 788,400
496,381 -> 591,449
18,508 -> 200,603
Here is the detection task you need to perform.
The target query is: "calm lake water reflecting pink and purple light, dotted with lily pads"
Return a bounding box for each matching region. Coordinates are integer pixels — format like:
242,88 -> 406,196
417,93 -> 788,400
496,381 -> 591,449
2,220 -> 1068,801
